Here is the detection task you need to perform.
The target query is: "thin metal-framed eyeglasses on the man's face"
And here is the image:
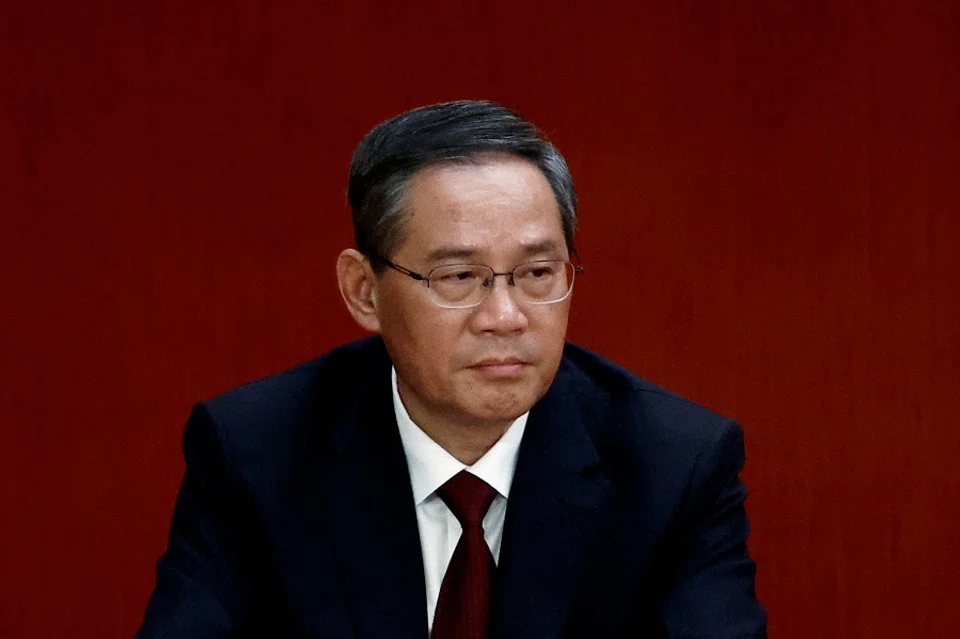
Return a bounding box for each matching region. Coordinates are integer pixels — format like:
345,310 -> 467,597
378,258 -> 583,308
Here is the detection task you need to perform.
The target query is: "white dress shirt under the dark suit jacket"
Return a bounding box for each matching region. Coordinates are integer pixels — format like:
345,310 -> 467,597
393,369 -> 530,630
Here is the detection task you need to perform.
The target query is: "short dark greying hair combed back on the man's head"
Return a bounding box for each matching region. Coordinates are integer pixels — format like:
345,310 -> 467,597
347,100 -> 577,270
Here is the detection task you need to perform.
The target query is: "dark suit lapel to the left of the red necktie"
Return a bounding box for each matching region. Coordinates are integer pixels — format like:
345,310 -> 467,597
323,353 -> 427,639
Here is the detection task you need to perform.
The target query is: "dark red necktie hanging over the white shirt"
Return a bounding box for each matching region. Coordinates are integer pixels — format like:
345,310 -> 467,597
430,470 -> 497,639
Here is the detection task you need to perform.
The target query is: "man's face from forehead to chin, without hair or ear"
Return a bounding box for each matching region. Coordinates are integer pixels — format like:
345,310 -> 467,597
376,156 -> 570,427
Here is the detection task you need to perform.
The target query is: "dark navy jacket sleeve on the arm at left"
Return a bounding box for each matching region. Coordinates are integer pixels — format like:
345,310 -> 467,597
137,404 -> 260,639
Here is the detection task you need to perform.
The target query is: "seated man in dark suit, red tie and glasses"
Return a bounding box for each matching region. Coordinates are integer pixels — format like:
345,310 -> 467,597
140,101 -> 765,639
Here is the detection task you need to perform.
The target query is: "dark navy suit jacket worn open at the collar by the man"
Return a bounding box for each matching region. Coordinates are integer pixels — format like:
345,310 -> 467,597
138,338 -> 766,639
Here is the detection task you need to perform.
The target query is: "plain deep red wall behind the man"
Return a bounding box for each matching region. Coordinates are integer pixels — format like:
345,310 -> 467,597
0,0 -> 960,639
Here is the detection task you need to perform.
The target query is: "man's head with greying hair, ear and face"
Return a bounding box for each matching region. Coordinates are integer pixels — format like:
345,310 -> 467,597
337,101 -> 576,444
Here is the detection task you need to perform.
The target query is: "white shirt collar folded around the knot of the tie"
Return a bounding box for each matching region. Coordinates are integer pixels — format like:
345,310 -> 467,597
391,368 -> 530,505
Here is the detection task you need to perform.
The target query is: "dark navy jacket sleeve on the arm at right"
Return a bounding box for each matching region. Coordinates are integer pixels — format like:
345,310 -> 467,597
660,422 -> 766,639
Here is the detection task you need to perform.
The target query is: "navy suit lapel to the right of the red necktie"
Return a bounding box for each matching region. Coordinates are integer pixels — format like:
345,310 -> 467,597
490,368 -> 613,639
